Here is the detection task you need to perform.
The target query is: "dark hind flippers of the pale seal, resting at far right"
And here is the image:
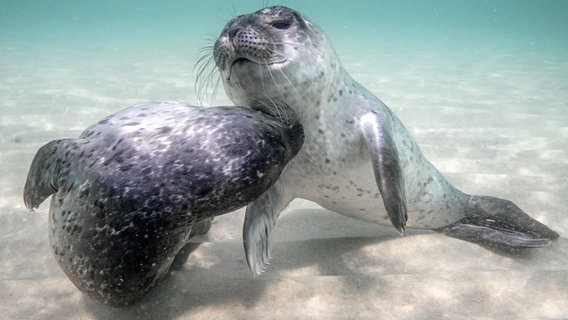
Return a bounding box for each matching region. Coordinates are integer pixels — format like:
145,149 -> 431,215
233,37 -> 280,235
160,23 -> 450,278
435,196 -> 559,248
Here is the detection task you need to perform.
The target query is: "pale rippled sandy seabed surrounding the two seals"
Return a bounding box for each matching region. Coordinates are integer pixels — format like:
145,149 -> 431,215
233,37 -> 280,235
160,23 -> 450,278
0,36 -> 568,320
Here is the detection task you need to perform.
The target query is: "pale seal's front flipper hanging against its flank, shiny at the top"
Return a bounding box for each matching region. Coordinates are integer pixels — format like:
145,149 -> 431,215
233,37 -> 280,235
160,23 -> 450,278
360,112 -> 408,233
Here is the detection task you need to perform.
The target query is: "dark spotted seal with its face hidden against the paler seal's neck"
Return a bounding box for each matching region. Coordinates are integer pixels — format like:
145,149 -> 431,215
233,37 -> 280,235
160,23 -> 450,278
24,101 -> 303,307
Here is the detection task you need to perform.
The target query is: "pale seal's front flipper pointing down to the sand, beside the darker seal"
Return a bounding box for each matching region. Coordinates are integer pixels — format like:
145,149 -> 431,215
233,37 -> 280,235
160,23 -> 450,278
243,182 -> 292,274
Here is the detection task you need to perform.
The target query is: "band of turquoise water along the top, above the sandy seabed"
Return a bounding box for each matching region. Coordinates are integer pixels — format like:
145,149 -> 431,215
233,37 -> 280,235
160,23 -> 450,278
0,0 -> 568,55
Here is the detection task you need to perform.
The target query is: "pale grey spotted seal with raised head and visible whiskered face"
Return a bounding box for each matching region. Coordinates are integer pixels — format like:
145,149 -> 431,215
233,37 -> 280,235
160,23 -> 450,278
209,6 -> 558,273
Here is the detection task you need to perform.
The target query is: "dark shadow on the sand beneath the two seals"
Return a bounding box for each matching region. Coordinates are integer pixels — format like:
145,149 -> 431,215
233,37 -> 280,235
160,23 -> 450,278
83,209 -> 398,319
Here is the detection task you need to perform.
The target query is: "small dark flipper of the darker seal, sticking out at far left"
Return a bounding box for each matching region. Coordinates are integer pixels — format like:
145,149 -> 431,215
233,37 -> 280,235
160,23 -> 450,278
24,139 -> 71,211
